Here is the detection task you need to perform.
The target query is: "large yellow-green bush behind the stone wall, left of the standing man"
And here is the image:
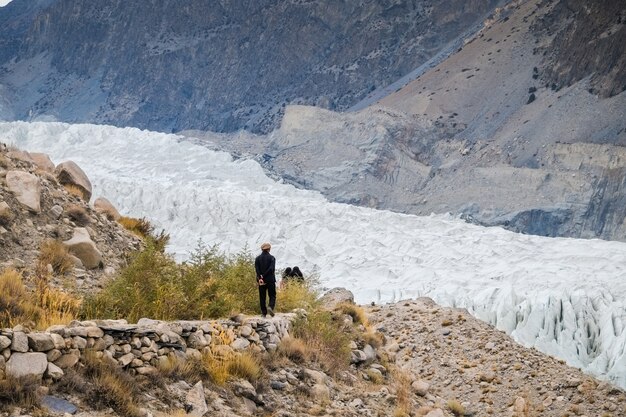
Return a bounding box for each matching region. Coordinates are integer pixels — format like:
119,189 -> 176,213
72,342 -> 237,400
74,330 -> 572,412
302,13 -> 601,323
82,240 -> 258,322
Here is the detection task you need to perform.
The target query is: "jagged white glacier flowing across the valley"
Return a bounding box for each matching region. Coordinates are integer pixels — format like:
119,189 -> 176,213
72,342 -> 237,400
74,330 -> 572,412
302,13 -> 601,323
0,122 -> 626,388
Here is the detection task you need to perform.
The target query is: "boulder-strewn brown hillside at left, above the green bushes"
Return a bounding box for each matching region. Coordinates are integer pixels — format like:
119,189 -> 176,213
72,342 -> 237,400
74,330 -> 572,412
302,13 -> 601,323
0,144 -> 141,292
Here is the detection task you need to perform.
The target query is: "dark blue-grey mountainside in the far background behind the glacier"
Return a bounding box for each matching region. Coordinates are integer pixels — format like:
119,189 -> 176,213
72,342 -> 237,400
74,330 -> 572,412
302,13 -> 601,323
0,0 -> 501,132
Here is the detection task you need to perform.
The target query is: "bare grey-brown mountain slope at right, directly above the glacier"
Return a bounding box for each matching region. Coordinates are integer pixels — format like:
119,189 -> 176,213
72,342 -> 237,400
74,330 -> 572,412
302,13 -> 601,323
199,0 -> 626,240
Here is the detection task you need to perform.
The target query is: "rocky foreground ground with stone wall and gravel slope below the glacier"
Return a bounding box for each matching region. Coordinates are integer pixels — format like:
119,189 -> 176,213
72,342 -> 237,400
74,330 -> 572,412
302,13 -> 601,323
0,290 -> 626,417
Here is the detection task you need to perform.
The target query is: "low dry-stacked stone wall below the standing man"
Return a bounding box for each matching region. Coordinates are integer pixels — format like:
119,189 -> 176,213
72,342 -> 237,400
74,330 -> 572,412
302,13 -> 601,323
0,314 -> 295,380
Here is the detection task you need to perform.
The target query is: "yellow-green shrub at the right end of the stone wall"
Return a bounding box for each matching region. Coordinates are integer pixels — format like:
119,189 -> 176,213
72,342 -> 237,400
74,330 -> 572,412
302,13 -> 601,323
293,311 -> 350,373
